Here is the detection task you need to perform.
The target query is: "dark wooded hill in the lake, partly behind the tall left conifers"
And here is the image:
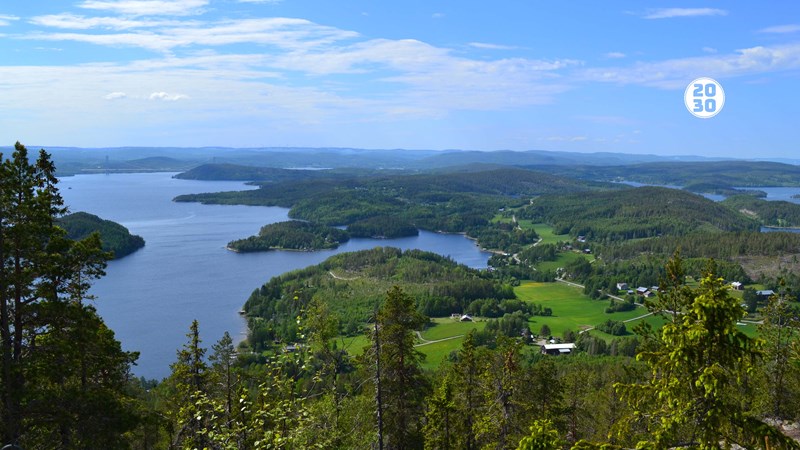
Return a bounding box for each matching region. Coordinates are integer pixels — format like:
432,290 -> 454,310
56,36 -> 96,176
58,212 -> 144,258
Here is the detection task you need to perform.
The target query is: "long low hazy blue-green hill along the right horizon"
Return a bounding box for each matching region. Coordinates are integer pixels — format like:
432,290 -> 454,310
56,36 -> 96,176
530,161 -> 800,192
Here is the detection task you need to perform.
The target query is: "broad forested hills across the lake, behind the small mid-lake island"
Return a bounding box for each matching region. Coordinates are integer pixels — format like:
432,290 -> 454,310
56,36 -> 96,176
175,168 -> 612,253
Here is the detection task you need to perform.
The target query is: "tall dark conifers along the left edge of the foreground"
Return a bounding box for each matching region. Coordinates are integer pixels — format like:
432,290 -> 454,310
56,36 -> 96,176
0,143 -> 140,448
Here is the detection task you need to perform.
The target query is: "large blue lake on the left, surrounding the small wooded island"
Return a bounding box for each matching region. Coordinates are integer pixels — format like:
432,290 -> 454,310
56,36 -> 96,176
59,173 -> 490,379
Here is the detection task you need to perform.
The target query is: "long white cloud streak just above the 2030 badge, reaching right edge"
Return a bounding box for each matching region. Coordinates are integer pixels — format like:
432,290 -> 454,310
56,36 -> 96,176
578,44 -> 800,89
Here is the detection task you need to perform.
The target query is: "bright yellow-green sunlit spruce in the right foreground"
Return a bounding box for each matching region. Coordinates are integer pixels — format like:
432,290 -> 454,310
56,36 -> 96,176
619,256 -> 792,449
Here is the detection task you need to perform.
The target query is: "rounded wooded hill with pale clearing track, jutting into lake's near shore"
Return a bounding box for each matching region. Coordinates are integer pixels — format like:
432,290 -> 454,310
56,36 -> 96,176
244,248 -> 514,349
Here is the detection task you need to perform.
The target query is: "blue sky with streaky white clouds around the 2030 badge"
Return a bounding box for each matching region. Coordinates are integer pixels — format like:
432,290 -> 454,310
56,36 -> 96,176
0,0 -> 800,158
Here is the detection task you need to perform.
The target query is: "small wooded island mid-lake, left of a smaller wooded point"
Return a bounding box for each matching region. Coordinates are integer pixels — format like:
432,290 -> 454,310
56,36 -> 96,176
227,220 -> 350,253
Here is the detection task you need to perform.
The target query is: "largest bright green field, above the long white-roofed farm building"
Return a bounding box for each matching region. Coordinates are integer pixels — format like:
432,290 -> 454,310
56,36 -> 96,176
514,282 -> 647,336
